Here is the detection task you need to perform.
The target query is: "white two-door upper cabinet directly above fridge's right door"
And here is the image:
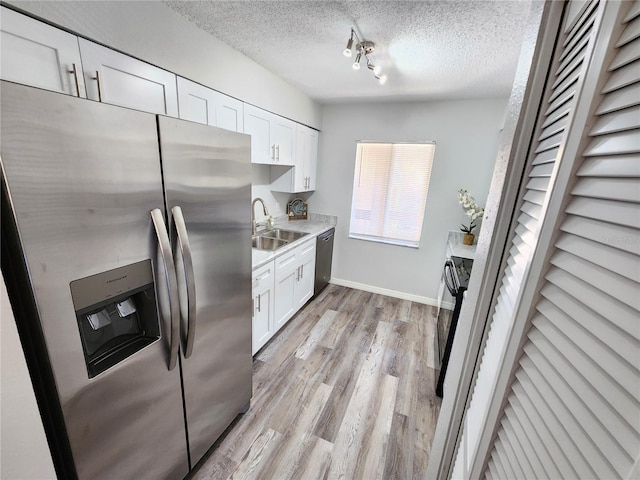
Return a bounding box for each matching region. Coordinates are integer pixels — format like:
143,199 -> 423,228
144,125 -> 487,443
178,77 -> 244,132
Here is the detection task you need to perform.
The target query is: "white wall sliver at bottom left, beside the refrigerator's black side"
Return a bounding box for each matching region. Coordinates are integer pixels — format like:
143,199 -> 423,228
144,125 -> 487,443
0,278 -> 56,480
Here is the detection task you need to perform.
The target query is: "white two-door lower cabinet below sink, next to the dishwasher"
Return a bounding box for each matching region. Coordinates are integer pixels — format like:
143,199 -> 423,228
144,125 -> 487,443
274,237 -> 316,331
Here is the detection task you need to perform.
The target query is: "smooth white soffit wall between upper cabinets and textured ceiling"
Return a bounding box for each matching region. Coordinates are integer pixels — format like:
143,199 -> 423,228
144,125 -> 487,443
7,0 -> 321,128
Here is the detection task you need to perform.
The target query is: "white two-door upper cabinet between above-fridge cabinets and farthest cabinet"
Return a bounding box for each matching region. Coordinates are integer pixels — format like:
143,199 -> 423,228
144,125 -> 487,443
244,103 -> 296,165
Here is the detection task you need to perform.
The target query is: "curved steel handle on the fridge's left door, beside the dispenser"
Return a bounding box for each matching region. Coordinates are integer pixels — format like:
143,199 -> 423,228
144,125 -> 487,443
151,208 -> 180,370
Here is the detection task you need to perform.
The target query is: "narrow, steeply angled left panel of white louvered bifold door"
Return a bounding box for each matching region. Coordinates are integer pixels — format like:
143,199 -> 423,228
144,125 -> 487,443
453,1 -> 599,478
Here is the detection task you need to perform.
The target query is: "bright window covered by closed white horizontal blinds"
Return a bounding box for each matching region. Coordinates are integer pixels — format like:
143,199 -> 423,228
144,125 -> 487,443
349,143 -> 435,248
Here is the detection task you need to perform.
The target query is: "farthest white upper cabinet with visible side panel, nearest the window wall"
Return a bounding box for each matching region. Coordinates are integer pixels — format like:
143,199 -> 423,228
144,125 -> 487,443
271,124 -> 318,193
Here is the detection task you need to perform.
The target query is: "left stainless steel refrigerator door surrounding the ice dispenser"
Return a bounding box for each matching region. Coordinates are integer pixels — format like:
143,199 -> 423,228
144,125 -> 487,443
0,82 -> 188,480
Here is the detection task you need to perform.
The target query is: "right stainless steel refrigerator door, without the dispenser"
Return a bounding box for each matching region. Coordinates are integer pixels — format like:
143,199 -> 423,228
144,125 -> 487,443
158,117 -> 252,465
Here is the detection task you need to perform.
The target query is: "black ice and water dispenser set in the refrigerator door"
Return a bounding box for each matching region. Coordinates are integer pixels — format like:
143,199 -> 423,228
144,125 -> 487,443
70,260 -> 160,378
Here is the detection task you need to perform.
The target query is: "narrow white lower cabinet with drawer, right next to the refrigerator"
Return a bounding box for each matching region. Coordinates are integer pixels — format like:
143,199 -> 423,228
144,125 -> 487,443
251,261 -> 274,355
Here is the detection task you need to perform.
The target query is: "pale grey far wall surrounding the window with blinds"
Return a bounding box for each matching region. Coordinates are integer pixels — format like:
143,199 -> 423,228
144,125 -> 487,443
309,99 -> 507,303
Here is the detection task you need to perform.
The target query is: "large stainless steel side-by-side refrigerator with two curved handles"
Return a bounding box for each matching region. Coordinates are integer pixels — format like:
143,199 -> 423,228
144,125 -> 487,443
0,82 -> 252,479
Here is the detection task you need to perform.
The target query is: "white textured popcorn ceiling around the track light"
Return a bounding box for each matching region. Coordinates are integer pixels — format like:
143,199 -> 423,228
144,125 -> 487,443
165,0 -> 530,103
